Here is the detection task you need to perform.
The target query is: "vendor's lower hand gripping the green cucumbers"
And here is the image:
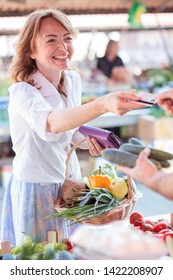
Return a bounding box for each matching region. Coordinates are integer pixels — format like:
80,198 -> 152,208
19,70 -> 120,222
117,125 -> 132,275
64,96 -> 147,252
118,148 -> 158,185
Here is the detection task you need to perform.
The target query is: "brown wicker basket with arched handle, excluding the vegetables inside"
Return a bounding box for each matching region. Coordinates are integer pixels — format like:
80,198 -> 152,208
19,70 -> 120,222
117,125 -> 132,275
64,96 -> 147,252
55,140 -> 142,224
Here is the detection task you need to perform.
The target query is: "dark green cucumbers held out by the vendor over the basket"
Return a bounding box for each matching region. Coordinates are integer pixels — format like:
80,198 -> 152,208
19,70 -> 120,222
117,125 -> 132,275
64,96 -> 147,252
101,137 -> 173,169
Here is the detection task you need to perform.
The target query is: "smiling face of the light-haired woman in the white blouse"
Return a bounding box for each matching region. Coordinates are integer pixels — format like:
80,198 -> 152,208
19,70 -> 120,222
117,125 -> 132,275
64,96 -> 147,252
30,17 -> 73,81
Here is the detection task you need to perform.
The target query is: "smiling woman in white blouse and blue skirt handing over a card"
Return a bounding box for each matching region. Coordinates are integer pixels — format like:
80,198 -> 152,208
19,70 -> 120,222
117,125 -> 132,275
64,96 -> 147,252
1,9 -> 145,246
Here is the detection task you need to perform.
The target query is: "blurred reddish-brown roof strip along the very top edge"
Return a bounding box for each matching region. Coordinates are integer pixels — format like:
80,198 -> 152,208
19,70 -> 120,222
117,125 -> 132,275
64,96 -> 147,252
0,0 -> 173,17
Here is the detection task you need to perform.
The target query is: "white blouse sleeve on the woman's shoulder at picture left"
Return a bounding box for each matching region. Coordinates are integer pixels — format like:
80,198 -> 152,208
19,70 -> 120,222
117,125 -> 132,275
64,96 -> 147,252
8,82 -> 57,141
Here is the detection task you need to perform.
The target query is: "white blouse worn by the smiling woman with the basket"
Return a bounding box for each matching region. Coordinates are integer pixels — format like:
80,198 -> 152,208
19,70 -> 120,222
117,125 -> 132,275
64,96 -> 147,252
8,70 -> 81,185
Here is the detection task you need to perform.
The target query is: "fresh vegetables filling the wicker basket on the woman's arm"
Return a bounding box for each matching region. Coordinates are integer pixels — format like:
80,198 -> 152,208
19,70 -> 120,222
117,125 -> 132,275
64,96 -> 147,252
46,164 -> 140,223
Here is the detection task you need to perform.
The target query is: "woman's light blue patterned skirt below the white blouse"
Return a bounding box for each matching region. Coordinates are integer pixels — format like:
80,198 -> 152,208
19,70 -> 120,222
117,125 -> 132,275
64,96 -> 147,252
1,175 -> 77,246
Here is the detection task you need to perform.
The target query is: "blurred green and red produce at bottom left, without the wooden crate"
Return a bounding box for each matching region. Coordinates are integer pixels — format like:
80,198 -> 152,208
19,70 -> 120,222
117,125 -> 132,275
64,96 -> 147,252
2,234 -> 75,260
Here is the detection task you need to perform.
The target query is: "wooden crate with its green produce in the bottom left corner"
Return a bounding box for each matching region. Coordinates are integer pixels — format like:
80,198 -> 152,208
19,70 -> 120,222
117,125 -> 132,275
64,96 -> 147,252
0,230 -> 74,260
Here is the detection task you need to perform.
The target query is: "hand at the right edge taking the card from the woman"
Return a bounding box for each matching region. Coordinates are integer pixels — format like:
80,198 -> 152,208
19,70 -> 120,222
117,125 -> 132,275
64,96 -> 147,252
156,89 -> 173,115
